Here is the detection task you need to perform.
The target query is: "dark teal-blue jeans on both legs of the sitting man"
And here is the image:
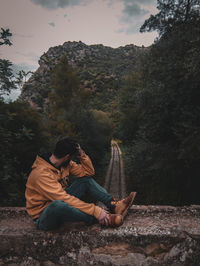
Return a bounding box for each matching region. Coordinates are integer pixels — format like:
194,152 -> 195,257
35,177 -> 112,231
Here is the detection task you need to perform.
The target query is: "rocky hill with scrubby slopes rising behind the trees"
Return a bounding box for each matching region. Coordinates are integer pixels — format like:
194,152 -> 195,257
20,42 -> 147,109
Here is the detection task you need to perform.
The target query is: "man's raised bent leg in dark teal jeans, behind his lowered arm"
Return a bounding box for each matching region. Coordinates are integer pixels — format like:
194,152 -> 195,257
66,177 -> 113,209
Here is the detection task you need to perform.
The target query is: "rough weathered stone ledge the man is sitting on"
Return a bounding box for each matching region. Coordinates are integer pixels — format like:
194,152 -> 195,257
0,205 -> 200,266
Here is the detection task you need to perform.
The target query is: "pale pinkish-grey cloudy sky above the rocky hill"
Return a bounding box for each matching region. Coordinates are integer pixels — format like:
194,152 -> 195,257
0,0 -> 158,71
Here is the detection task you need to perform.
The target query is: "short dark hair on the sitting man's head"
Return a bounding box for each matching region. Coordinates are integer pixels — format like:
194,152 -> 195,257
53,137 -> 78,158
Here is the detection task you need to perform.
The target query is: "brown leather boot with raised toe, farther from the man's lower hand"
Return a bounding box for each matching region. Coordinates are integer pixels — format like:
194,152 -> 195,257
112,192 -> 137,218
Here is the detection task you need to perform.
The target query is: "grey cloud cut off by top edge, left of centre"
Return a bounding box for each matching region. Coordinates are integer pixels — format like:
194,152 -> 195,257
31,0 -> 91,9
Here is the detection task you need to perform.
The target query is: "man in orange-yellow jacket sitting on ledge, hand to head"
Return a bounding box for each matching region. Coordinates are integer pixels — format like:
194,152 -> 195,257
25,137 -> 136,230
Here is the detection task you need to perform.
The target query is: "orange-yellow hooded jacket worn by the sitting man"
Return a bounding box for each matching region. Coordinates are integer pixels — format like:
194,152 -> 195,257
25,154 -> 101,219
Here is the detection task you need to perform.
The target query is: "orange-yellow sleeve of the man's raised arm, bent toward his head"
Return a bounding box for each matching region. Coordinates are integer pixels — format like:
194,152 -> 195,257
69,154 -> 95,177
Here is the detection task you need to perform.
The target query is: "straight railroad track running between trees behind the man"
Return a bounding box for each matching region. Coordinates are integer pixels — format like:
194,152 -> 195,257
104,140 -> 126,199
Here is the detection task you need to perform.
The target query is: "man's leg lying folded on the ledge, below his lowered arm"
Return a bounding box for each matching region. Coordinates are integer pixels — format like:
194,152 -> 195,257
37,200 -> 95,231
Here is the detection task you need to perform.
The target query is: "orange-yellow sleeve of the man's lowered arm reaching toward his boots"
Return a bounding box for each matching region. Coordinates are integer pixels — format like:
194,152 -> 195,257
35,171 -> 101,218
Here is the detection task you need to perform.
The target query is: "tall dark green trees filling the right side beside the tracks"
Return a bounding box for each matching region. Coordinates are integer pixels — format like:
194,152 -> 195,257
116,1 -> 200,205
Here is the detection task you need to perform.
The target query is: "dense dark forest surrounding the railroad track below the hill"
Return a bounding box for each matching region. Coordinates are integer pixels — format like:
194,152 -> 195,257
0,0 -> 200,206
